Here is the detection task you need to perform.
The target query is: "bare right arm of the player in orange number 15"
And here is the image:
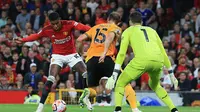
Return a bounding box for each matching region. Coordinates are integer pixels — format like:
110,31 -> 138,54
99,32 -> 115,63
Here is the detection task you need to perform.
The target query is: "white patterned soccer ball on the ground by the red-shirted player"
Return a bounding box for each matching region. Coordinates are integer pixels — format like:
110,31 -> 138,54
52,100 -> 67,112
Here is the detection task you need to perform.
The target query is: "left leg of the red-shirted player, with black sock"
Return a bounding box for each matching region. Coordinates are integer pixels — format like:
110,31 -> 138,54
36,64 -> 61,112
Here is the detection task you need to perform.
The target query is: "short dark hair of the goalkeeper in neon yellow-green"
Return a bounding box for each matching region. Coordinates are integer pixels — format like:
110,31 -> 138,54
129,12 -> 142,23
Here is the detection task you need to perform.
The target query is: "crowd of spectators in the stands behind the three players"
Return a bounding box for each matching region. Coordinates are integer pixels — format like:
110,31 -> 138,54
0,0 -> 200,109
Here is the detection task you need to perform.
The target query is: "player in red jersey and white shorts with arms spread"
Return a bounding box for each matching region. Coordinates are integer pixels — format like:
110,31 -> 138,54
16,12 -> 90,112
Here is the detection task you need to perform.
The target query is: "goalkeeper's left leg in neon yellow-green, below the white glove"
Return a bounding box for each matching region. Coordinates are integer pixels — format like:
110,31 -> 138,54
115,60 -> 145,112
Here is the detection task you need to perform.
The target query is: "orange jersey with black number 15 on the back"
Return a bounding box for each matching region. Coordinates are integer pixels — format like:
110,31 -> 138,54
85,23 -> 122,61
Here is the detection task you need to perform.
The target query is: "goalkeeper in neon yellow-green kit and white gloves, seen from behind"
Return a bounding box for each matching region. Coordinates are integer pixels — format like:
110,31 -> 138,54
106,12 -> 178,112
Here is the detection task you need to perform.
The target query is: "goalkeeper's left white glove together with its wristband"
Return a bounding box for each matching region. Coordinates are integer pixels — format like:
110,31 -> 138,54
106,64 -> 121,90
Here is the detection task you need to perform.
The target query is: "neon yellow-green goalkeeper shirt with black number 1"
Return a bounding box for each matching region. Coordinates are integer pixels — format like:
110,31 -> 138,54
116,25 -> 171,68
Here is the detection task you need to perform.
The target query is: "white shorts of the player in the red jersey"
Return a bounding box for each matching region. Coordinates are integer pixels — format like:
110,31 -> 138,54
50,53 -> 83,68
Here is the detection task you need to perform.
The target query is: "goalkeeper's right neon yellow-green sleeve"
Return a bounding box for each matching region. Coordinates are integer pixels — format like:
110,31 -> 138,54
155,32 -> 171,69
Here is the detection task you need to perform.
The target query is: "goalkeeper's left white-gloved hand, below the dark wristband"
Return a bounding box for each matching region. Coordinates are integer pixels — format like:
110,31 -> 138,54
106,72 -> 118,90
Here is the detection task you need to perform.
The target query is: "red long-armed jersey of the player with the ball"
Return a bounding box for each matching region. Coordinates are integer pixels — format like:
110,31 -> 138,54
22,20 -> 90,55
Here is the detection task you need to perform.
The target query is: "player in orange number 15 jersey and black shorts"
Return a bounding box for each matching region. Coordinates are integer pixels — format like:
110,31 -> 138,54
77,12 -> 140,112
